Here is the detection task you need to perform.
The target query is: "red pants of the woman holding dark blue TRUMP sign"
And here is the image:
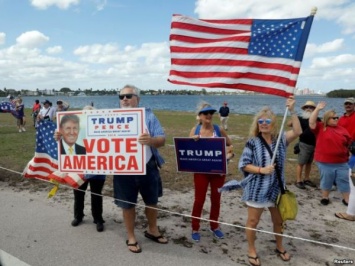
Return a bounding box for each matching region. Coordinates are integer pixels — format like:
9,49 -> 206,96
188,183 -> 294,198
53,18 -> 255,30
192,174 -> 226,231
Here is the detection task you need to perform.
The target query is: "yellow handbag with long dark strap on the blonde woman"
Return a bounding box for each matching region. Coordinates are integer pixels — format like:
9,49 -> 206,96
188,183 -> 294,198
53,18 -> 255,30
259,135 -> 298,221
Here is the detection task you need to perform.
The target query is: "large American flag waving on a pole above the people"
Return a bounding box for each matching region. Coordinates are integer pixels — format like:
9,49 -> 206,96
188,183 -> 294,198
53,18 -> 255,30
168,15 -> 313,97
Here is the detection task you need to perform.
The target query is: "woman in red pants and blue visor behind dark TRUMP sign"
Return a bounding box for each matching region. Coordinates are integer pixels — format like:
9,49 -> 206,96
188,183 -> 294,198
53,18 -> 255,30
190,102 -> 232,242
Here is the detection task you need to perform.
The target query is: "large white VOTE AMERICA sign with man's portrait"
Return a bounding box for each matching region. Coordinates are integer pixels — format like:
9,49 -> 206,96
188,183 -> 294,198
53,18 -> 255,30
57,108 -> 146,175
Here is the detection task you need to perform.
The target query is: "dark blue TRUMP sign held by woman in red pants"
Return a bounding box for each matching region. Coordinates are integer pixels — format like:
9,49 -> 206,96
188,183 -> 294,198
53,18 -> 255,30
174,138 -> 227,175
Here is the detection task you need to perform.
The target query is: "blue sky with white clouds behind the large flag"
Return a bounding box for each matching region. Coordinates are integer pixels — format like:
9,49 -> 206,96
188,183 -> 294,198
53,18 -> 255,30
0,0 -> 355,93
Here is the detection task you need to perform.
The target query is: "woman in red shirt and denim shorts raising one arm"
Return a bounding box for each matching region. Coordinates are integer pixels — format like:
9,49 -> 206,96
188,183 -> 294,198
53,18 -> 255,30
309,102 -> 351,206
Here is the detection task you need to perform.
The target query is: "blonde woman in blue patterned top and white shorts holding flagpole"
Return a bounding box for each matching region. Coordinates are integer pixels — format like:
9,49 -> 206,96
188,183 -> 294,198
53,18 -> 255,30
239,97 -> 302,266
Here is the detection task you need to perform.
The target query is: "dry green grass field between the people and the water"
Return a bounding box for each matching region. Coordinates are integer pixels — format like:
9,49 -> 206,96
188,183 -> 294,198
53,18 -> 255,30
0,109 -> 318,191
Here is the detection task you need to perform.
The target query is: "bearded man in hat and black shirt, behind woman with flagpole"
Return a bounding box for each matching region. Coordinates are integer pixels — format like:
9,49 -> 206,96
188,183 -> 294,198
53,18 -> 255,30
288,101 -> 320,189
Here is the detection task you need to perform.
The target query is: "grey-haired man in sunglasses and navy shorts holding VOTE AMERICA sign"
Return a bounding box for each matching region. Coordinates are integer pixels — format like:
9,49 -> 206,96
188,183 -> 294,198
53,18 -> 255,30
113,85 -> 168,253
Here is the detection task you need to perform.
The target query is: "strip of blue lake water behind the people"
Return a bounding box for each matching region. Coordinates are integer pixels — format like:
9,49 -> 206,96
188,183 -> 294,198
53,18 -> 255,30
1,94 -> 344,115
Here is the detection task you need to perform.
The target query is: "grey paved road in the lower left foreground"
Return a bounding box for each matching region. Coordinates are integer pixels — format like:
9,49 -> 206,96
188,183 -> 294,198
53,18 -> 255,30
0,182 -> 235,266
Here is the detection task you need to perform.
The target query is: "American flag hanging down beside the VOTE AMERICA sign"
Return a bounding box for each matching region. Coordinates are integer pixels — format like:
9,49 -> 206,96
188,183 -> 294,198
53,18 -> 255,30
23,121 -> 85,188
